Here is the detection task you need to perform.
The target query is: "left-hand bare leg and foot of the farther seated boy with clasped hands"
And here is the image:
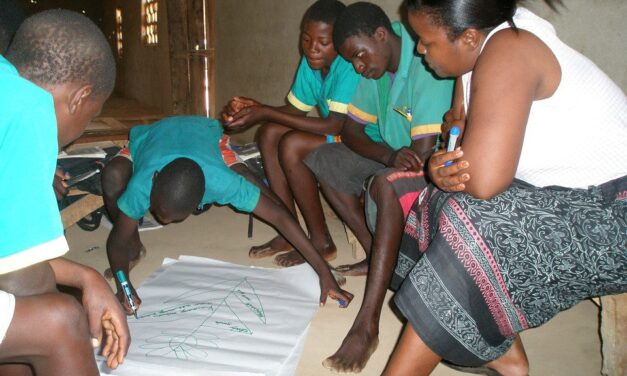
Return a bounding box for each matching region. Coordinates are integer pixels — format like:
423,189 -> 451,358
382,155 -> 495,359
249,123 -> 296,258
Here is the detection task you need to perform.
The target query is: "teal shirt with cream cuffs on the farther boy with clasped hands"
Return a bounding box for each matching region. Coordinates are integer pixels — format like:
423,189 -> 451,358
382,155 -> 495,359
287,55 -> 360,118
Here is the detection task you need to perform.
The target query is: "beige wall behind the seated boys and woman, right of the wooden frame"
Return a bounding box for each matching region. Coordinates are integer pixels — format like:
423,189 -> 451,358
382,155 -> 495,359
216,0 -> 627,141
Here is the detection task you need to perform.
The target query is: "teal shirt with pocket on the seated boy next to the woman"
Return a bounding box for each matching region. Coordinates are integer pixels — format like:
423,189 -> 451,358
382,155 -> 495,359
348,22 -> 454,150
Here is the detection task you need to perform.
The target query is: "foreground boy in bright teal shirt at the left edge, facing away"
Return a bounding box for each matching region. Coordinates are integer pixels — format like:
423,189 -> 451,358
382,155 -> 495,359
0,10 -> 130,376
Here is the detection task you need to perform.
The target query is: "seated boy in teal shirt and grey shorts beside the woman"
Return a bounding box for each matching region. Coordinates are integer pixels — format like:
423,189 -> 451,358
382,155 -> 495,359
305,2 -> 454,372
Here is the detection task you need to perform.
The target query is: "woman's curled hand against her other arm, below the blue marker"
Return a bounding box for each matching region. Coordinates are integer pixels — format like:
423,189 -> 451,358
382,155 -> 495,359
429,147 -> 470,192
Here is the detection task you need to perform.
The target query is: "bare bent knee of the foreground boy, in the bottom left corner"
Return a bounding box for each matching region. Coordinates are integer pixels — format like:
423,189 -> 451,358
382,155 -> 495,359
0,293 -> 99,376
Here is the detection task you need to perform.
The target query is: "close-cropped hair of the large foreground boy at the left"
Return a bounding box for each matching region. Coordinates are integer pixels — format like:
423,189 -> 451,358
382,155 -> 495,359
6,9 -> 115,96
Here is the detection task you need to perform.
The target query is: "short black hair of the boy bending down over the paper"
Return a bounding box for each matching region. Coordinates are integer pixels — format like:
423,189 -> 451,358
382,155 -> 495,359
151,158 -> 205,214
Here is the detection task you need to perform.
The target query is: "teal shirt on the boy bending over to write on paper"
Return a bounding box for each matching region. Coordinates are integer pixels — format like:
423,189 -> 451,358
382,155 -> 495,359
118,116 -> 260,219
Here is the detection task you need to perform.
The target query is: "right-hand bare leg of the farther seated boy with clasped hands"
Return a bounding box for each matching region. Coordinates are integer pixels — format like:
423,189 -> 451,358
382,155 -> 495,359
277,131 -> 337,267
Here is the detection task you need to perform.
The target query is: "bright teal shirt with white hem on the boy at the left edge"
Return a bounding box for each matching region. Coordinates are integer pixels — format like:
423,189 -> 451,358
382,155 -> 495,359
0,56 -> 68,274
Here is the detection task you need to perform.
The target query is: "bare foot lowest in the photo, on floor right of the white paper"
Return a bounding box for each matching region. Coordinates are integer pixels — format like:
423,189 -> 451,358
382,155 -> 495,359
322,326 -> 379,373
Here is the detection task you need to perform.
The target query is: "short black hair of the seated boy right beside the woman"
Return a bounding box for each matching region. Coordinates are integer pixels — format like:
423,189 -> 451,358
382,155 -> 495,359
333,2 -> 392,48
